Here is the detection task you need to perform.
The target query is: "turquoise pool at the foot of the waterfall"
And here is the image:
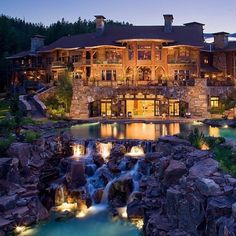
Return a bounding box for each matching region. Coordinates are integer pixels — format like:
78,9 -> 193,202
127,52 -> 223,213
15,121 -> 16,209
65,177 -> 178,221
20,209 -> 140,236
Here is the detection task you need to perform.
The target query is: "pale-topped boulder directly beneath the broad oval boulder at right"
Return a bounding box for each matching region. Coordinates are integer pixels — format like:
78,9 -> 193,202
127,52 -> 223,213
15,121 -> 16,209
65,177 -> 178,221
195,178 -> 220,196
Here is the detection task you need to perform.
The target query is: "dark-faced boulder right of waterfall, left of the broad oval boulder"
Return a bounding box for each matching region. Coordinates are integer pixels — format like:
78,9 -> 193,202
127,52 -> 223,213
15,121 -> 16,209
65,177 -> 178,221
164,160 -> 187,185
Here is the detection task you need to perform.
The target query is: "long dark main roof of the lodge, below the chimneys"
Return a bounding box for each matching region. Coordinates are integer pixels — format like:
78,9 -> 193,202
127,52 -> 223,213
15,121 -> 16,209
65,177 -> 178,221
40,25 -> 203,52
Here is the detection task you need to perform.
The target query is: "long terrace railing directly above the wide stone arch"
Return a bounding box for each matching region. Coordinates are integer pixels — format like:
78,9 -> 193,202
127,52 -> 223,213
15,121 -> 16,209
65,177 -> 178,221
84,79 -> 195,87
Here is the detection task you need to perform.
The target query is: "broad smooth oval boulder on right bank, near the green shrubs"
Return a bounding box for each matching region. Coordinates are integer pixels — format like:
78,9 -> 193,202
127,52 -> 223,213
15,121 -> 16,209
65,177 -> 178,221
189,158 -> 219,178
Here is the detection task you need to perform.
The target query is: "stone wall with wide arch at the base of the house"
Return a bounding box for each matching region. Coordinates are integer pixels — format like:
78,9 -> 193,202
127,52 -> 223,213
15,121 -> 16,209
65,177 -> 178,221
70,79 -> 234,119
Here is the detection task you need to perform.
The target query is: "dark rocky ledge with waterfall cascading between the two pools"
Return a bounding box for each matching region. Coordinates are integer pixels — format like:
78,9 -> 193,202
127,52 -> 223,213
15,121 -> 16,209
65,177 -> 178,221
0,133 -> 236,236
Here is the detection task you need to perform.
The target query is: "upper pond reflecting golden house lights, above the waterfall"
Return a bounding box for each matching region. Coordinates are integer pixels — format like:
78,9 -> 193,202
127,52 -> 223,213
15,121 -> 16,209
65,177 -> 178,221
70,122 -> 236,140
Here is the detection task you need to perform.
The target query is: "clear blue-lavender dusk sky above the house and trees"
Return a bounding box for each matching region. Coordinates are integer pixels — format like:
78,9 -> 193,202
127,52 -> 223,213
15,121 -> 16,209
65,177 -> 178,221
0,0 -> 236,33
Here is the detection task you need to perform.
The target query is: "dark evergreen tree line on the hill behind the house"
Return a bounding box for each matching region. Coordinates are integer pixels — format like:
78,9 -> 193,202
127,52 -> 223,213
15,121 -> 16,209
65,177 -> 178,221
0,15 -> 129,91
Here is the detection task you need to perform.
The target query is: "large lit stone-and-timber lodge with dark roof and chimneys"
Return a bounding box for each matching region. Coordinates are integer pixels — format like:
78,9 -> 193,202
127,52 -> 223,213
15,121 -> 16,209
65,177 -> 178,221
7,15 -> 236,118
